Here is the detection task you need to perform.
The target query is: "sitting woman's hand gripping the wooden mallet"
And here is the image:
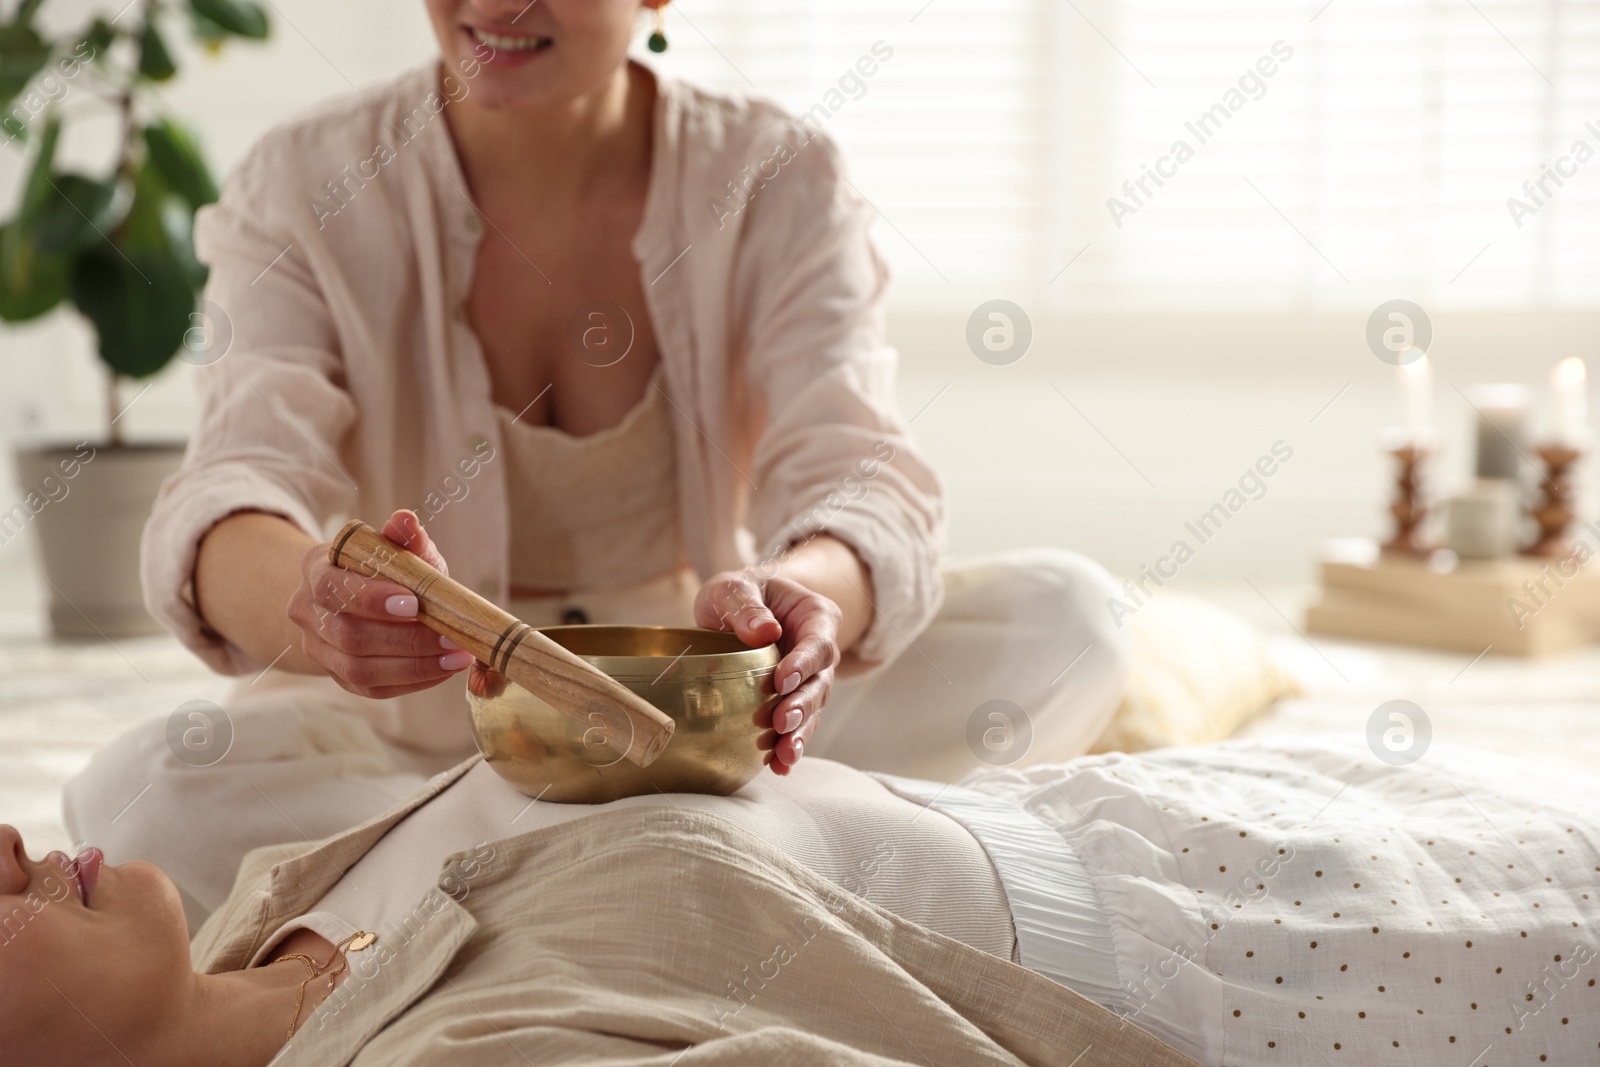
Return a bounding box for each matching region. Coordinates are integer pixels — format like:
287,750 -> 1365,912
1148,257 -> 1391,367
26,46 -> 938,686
288,510 -> 472,701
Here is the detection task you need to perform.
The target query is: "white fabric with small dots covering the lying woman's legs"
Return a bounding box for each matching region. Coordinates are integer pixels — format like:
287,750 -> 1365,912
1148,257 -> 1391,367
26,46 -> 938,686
966,742 -> 1600,1067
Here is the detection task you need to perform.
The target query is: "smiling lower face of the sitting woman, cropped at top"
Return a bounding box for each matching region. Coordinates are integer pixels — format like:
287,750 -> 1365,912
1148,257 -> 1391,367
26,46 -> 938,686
427,0 -> 666,107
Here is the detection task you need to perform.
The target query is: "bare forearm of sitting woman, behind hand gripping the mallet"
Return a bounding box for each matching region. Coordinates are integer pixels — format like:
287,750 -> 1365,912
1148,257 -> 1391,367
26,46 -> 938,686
195,512 -> 326,673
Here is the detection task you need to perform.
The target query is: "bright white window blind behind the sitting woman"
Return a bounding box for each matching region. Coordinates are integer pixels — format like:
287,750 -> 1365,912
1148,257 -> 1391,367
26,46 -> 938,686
654,0 -> 1600,314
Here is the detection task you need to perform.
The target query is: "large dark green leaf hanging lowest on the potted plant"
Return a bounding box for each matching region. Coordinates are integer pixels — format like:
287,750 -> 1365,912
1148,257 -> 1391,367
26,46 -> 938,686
69,242 -> 195,378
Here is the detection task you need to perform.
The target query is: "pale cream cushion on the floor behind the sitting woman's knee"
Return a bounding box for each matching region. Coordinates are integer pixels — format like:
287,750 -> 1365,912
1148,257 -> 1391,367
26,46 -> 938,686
1090,592 -> 1301,752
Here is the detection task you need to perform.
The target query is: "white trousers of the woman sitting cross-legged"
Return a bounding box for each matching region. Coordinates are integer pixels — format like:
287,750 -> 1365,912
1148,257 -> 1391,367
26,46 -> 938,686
62,549 -> 1128,923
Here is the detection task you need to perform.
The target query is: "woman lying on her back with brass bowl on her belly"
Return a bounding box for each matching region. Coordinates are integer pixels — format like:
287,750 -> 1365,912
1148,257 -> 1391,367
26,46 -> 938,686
0,742 -> 1600,1067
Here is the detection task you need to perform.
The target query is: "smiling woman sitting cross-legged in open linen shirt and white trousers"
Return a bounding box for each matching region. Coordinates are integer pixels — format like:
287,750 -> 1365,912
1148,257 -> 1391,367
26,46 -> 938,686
66,0 -> 1131,925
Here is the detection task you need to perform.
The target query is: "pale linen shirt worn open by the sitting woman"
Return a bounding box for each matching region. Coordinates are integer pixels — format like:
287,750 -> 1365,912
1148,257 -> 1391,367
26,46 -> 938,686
142,62 -> 944,753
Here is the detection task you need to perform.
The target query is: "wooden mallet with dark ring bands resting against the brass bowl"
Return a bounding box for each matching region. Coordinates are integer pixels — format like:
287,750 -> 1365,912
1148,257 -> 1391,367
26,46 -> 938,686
328,518 -> 672,766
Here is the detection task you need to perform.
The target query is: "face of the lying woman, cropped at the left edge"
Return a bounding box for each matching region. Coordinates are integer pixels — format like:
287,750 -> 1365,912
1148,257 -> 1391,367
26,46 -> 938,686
0,825 -> 194,1064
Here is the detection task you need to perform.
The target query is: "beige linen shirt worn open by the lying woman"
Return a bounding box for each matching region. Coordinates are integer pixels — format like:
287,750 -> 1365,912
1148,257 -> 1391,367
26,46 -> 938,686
192,760 -> 1195,1067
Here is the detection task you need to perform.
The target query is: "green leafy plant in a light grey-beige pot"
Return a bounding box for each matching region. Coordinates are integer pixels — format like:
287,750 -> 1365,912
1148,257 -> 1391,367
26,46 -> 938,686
0,0 -> 269,637
